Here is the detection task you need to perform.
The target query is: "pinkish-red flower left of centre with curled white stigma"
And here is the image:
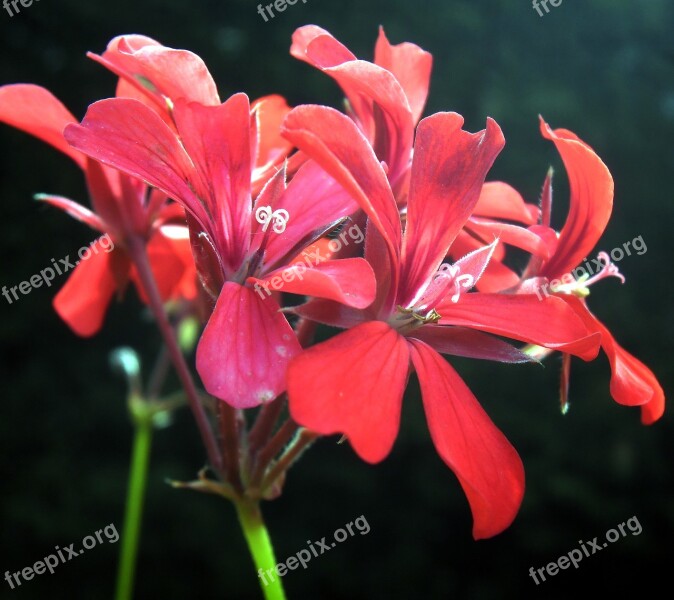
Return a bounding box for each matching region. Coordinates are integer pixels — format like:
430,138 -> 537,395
66,94 -> 374,408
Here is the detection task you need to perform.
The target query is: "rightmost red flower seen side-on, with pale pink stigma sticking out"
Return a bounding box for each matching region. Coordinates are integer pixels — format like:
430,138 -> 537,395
524,119 -> 665,424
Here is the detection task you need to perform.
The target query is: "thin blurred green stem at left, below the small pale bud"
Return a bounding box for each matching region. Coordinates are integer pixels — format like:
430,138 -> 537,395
115,400 -> 152,600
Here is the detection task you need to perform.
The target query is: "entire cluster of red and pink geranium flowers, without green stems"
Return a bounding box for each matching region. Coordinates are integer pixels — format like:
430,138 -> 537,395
0,26 -> 664,539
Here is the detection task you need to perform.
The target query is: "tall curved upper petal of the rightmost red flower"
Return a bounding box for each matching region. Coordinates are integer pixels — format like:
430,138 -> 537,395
540,118 -> 613,279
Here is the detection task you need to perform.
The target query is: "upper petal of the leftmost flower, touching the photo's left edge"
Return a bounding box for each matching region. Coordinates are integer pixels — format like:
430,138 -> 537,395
0,83 -> 86,169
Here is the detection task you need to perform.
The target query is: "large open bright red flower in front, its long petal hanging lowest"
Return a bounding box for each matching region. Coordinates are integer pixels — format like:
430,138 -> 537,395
284,106 -> 599,538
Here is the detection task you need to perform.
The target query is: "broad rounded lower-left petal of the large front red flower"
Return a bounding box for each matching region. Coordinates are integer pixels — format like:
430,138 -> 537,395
288,321 -> 409,463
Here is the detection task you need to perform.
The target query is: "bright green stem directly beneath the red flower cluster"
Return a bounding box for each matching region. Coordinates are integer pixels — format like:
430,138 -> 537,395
235,499 -> 285,600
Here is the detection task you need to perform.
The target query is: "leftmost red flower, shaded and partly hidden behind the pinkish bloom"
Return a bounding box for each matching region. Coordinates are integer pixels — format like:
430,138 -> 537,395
0,84 -> 196,336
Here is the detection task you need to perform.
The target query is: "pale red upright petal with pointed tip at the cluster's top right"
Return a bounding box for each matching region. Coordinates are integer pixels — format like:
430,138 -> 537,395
374,27 -> 433,123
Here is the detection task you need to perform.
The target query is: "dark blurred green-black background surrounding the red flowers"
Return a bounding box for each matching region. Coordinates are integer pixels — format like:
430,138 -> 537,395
0,0 -> 674,599
